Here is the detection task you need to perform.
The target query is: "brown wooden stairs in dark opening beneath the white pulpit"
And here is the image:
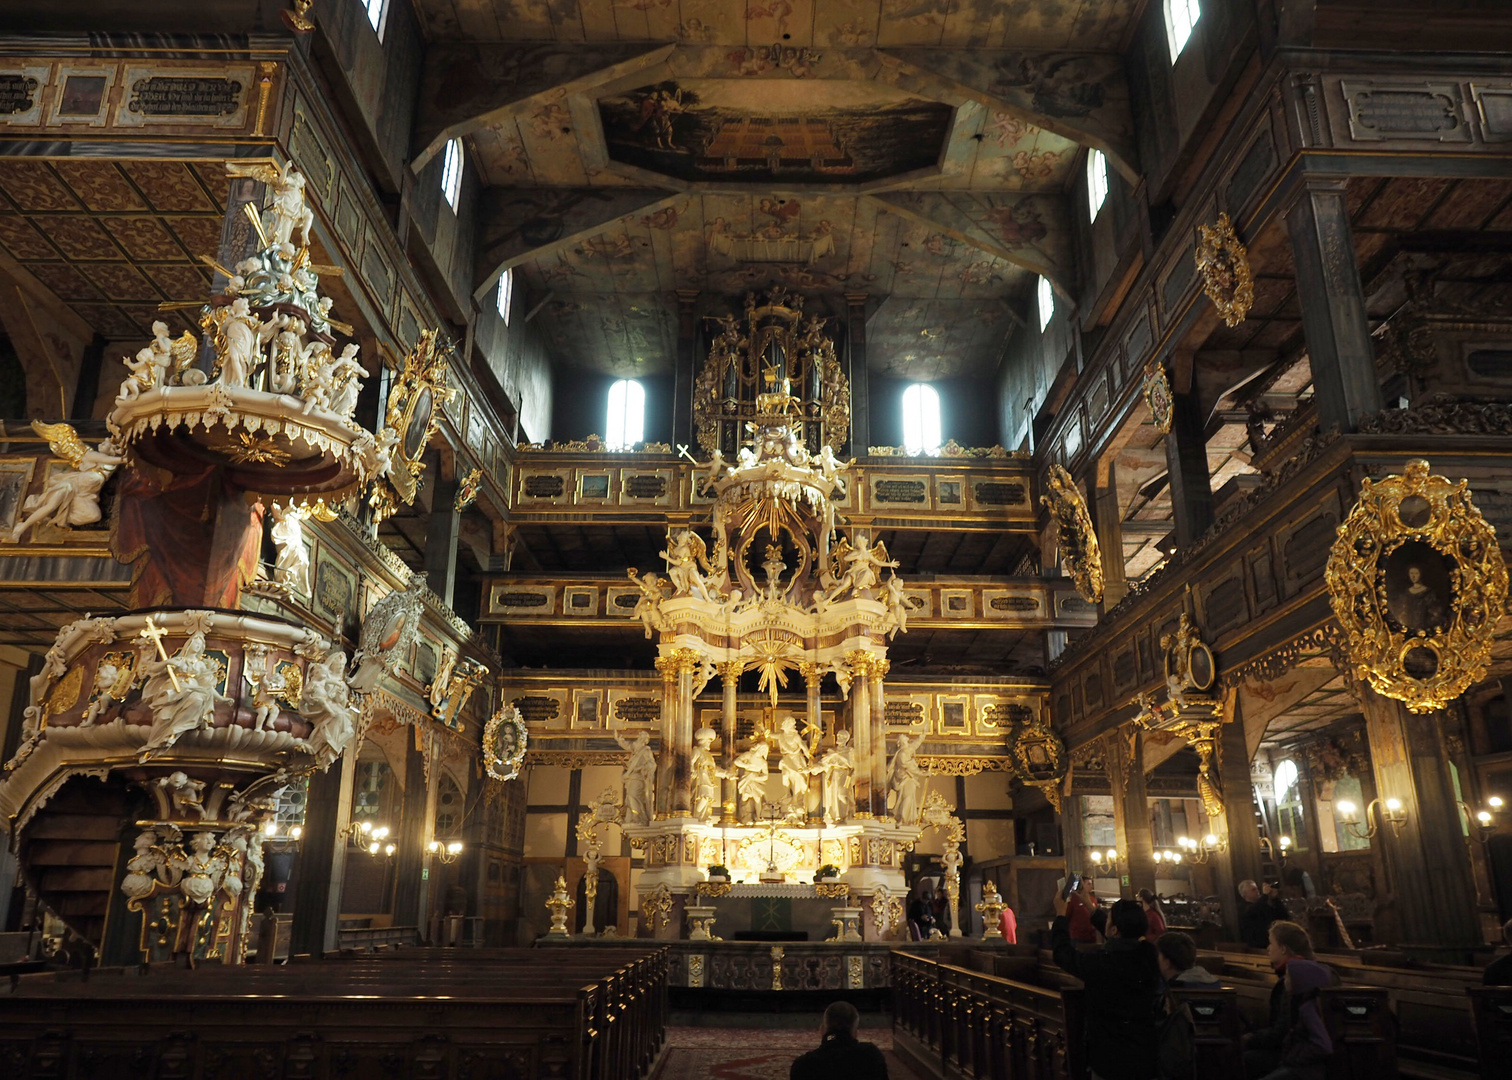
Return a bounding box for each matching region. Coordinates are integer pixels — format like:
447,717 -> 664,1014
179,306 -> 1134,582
21,777 -> 136,950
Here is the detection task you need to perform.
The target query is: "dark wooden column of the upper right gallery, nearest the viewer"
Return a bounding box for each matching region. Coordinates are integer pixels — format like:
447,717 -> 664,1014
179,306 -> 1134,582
1287,177 -> 1382,431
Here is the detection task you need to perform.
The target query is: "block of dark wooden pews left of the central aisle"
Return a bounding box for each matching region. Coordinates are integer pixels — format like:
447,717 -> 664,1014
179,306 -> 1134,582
0,942 -> 667,1080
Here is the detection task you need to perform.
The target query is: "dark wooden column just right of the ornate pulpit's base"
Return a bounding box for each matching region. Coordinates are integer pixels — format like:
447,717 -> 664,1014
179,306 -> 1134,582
289,755 -> 352,957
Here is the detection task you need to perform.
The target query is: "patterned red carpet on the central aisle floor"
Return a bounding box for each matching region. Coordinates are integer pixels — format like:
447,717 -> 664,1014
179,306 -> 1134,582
656,1027 -> 916,1080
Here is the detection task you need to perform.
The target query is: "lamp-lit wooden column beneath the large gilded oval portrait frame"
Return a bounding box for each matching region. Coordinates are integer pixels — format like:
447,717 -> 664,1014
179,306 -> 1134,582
1358,687 -> 1480,943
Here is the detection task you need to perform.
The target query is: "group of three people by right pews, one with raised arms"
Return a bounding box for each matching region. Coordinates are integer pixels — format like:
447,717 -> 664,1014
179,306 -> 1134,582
1051,879 -> 1334,1080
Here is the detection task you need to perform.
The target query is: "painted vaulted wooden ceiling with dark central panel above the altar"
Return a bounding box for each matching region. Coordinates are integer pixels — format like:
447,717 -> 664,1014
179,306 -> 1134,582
432,0 -> 1142,378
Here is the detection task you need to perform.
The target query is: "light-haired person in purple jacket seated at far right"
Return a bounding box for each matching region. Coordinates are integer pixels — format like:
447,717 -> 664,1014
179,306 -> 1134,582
1244,920 -> 1334,1080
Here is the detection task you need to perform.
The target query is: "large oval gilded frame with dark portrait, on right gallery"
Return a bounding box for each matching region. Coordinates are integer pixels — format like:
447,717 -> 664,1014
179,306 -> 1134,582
1326,458 -> 1507,712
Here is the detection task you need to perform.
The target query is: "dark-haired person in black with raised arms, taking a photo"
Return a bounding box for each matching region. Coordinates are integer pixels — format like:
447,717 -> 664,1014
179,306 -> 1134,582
1049,889 -> 1166,1080
